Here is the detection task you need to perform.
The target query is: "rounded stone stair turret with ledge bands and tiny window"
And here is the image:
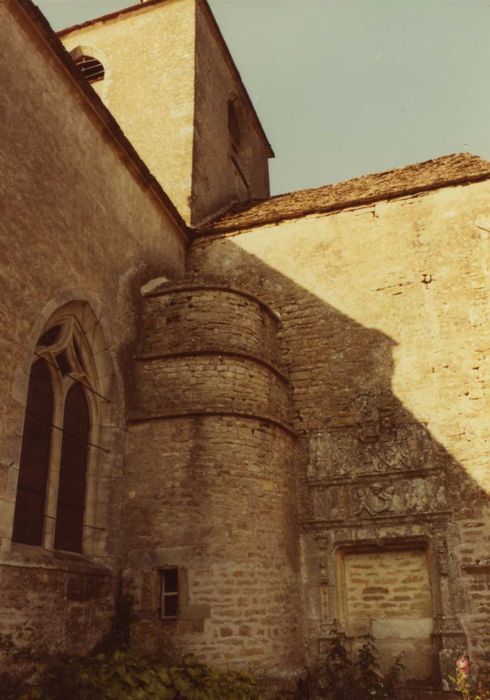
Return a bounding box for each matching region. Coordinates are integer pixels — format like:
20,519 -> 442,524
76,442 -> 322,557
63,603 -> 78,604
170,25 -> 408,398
123,281 -> 302,672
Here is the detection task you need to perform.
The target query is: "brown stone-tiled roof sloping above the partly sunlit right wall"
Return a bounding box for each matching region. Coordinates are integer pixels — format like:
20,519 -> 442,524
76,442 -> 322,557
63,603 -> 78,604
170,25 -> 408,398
198,153 -> 490,233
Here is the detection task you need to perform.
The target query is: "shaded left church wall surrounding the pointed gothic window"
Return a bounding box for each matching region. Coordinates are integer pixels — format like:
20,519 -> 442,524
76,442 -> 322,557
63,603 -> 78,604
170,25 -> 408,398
0,2 -> 185,651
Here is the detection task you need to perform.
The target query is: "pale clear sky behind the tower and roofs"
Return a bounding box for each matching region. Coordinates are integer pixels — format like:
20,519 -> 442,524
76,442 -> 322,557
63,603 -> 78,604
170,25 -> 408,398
37,0 -> 490,193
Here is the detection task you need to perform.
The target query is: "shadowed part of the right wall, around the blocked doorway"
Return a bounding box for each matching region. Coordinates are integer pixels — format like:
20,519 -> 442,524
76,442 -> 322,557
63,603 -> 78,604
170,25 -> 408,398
189,238 -> 490,685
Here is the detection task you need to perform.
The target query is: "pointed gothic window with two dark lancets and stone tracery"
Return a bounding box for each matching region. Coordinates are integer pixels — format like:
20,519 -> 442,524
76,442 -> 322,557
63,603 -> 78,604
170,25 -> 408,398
12,316 -> 98,552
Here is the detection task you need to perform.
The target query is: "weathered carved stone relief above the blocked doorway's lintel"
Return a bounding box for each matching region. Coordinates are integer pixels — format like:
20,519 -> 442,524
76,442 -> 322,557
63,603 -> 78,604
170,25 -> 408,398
306,395 -> 447,520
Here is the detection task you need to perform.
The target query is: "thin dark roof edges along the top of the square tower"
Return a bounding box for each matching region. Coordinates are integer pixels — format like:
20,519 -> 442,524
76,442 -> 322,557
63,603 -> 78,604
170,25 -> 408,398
57,0 -> 274,158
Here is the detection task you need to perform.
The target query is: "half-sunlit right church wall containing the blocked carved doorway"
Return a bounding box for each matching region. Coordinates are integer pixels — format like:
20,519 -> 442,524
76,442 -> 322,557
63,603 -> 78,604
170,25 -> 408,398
189,182 -> 490,680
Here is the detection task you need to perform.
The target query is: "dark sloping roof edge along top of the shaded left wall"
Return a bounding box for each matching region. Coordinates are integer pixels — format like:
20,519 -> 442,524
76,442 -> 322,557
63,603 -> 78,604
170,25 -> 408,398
13,0 -> 189,240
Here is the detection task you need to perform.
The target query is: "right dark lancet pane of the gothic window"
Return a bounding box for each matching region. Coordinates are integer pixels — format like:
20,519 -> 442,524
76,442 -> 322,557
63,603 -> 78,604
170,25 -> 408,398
54,384 -> 90,552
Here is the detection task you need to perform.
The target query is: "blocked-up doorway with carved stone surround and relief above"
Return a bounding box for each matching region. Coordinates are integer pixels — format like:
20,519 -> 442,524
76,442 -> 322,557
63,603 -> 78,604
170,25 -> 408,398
303,394 -> 464,678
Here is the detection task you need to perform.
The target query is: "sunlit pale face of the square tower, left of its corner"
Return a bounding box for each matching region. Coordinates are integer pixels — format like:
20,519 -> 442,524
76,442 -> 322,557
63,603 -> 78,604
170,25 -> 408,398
61,0 -> 196,221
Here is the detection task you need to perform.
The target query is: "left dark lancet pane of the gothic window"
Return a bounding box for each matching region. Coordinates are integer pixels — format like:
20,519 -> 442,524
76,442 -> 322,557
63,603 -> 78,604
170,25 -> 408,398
12,360 -> 53,545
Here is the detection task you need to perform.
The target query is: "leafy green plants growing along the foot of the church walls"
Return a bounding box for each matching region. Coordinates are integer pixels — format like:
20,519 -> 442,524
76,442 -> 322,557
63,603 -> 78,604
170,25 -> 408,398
0,595 -> 490,700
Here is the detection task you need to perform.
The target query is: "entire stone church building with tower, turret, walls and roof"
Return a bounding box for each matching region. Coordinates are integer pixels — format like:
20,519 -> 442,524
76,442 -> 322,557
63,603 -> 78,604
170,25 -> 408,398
0,0 -> 490,688
